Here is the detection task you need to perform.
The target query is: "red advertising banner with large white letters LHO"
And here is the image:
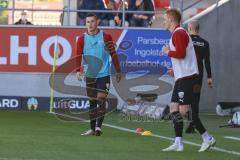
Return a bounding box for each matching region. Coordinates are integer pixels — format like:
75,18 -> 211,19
0,27 -> 122,72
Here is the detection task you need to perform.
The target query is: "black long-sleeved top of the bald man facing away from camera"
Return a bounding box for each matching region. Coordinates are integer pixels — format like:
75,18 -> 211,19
191,35 -> 212,78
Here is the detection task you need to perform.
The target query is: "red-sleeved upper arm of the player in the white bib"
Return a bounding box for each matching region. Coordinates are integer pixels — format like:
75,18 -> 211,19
168,31 -> 189,59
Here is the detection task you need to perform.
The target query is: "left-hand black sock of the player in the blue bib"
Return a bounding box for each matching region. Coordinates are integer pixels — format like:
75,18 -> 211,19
89,100 -> 97,131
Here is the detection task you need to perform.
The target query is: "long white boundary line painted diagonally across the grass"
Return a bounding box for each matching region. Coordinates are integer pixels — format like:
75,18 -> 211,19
53,113 -> 240,156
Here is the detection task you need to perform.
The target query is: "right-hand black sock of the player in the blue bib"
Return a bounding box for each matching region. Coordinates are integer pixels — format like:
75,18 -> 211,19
97,98 -> 106,128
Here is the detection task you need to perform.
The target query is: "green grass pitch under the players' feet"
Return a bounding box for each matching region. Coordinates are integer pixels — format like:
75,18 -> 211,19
0,111 -> 240,160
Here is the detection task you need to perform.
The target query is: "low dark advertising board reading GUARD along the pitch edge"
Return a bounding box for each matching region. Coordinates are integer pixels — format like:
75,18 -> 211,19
0,96 -> 117,112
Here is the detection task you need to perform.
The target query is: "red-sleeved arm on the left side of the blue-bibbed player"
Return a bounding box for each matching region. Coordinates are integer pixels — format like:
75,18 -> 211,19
76,36 -> 84,80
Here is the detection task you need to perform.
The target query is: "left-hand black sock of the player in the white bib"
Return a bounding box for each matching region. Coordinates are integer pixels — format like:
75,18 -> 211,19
171,111 -> 183,137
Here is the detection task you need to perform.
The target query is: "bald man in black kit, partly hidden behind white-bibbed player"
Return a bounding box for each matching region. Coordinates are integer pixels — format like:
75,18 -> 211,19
186,20 -> 213,133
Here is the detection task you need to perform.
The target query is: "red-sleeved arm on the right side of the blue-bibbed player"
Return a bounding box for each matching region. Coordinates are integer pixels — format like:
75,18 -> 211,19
104,33 -> 121,82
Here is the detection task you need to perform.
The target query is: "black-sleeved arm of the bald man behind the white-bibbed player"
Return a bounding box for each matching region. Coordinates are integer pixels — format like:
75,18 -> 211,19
203,42 -> 213,88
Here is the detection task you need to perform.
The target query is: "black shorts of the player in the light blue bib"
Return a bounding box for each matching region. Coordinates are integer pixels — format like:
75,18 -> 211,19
86,76 -> 110,94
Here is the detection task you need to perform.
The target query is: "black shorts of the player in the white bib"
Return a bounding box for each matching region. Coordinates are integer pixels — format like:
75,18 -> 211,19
171,77 -> 200,105
